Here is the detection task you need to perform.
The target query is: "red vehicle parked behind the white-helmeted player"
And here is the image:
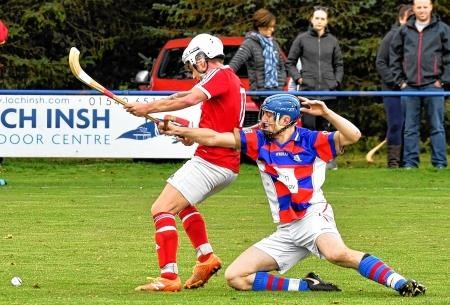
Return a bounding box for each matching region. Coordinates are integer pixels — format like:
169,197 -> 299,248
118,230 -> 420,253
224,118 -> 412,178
135,37 -> 259,127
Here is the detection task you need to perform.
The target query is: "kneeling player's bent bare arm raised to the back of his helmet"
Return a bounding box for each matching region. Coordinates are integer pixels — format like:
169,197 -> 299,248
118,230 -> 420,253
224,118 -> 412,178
299,97 -> 361,147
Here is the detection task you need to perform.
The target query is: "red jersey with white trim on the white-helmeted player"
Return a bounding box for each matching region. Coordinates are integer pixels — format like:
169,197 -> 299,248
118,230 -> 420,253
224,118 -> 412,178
195,66 -> 245,173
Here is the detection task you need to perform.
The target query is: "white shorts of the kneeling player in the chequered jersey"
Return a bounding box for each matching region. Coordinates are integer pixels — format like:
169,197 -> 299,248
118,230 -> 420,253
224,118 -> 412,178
254,203 -> 341,274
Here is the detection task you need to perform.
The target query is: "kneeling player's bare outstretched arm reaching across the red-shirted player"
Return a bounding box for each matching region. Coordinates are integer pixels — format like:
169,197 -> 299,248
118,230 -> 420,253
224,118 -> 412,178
158,122 -> 241,150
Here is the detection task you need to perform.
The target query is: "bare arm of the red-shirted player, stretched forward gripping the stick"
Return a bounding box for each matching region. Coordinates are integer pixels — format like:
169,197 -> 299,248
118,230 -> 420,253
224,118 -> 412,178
124,87 -> 207,116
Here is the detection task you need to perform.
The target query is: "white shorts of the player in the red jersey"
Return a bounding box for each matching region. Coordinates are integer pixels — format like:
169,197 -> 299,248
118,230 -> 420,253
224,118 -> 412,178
167,156 -> 237,205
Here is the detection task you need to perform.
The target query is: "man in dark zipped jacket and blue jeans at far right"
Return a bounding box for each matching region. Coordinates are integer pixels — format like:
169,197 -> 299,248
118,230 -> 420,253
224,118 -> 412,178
390,0 -> 450,169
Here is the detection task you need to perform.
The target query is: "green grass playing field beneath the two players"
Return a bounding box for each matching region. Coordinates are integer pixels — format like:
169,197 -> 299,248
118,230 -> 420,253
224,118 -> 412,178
0,159 -> 450,305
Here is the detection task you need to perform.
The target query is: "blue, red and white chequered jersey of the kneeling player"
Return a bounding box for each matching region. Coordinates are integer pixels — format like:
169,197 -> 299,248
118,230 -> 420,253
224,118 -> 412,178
240,127 -> 337,223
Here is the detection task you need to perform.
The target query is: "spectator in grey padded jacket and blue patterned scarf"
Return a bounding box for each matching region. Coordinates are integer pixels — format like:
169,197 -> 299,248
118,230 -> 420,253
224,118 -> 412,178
229,8 -> 287,105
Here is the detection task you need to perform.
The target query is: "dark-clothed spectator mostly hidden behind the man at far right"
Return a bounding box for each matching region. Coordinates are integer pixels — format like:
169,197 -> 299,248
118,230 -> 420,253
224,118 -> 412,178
375,4 -> 413,168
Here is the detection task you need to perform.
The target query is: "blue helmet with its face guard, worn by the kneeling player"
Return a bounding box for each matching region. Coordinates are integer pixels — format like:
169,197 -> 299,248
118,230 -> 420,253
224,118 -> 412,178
258,93 -> 300,138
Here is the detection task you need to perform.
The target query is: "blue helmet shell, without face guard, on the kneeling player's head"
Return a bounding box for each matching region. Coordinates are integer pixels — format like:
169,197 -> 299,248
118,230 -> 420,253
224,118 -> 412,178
259,93 -> 300,125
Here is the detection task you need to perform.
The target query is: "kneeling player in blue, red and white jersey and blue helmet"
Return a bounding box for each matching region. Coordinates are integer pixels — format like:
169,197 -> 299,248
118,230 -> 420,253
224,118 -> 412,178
159,94 -> 426,296
